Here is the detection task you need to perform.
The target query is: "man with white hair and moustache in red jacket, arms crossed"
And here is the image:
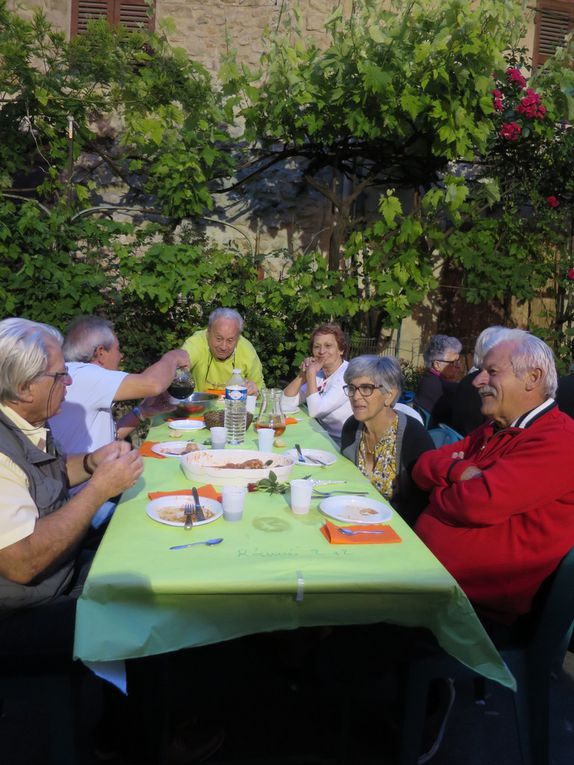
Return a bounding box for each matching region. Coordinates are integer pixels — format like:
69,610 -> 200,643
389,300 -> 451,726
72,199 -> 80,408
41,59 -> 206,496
413,330 -> 574,625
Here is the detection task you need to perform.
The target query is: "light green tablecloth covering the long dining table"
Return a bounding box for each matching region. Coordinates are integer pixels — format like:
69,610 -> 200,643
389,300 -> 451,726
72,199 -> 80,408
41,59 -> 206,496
75,413 -> 514,687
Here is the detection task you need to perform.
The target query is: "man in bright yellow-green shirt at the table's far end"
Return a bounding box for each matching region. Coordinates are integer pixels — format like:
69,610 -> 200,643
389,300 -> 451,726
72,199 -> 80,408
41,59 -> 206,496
183,308 -> 264,396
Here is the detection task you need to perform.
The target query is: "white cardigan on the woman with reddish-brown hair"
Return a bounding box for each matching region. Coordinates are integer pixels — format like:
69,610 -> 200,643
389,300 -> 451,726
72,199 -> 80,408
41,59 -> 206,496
281,361 -> 353,439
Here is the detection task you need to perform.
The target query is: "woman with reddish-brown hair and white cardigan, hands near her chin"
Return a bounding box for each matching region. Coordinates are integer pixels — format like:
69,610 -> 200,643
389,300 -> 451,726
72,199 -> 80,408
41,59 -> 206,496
282,324 -> 353,444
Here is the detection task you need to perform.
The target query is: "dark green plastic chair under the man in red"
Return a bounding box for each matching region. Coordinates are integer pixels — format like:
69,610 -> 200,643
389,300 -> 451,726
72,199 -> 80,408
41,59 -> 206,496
400,547 -> 574,765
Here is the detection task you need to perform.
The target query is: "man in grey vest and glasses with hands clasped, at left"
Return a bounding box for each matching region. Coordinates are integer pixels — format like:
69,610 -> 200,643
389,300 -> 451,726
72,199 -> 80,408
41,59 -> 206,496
0,318 -> 143,659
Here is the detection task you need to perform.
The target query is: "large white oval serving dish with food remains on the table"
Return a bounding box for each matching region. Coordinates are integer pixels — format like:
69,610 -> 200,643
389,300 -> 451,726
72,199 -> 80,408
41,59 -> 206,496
180,449 -> 295,485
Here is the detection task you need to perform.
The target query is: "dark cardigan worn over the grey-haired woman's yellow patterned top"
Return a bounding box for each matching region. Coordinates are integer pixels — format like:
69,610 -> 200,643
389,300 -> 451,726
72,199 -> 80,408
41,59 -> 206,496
341,412 -> 434,526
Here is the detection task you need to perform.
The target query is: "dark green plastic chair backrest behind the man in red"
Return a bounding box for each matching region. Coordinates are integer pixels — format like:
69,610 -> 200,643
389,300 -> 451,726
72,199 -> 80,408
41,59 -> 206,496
528,547 -> 574,663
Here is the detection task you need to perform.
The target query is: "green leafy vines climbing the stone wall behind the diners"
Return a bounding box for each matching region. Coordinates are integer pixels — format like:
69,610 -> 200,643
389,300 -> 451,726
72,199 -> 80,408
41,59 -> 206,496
0,0 -> 574,384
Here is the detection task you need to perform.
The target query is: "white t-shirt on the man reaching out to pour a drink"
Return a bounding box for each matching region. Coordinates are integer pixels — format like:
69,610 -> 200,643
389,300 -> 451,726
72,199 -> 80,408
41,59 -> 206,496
50,361 -> 128,454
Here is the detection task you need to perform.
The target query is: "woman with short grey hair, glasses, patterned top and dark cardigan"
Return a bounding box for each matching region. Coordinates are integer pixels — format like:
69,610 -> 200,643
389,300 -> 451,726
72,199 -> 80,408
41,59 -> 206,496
341,356 -> 434,525
